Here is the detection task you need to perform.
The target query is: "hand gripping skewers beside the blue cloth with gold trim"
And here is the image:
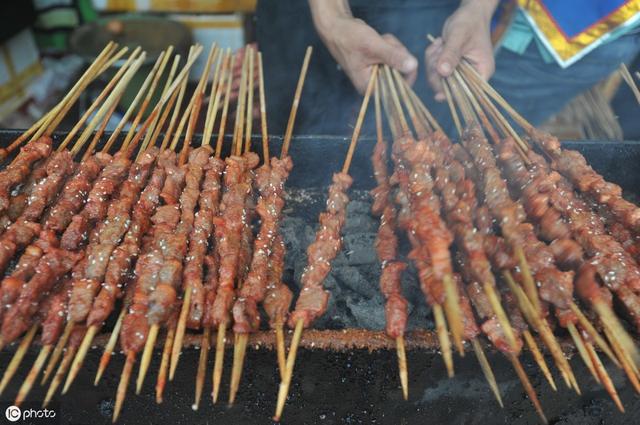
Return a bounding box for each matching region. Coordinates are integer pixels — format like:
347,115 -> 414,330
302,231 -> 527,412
425,0 -> 497,102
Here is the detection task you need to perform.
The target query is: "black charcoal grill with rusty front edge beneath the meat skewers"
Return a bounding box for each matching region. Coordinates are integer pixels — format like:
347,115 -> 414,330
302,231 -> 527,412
0,130 -> 640,425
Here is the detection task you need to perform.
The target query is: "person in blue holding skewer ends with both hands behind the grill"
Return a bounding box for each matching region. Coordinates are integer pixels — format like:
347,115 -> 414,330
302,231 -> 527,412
257,0 -> 640,134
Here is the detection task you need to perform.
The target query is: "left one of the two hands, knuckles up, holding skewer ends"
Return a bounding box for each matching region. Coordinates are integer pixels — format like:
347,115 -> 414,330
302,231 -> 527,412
314,5 -> 418,93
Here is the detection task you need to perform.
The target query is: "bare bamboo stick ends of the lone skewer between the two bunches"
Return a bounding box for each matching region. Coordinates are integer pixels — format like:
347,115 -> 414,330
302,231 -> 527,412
274,63 -> 378,421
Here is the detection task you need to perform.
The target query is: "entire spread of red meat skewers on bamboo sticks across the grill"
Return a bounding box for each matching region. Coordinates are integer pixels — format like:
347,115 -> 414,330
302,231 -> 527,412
0,37 -> 640,421
